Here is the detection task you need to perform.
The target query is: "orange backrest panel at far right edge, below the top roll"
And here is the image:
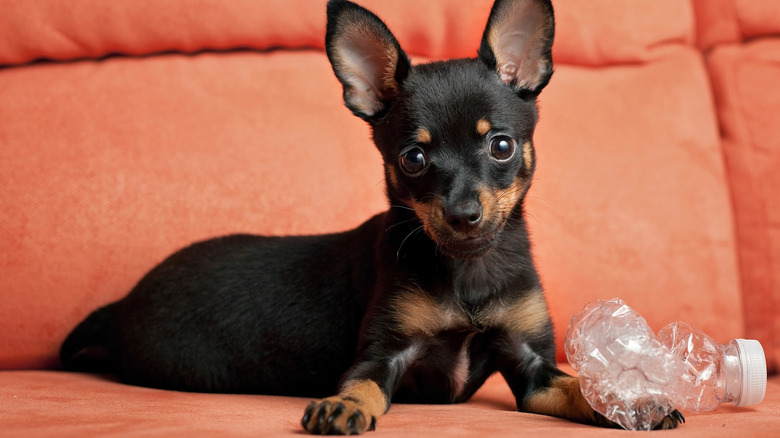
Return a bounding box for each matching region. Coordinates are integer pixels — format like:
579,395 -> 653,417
708,39 -> 780,369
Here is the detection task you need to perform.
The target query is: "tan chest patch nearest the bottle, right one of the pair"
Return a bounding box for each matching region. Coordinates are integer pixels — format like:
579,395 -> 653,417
492,289 -> 550,335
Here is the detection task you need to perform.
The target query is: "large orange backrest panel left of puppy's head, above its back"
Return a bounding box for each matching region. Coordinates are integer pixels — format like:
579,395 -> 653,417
0,52 -> 386,368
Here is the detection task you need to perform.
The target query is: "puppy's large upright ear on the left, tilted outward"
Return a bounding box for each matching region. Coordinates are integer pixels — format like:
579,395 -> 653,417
325,0 -> 411,121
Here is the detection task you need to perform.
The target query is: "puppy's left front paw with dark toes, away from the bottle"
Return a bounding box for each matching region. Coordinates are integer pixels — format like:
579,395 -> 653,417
301,397 -> 376,435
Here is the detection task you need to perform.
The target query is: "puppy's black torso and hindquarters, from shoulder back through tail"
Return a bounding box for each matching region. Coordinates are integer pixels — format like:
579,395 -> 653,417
60,218 -> 379,396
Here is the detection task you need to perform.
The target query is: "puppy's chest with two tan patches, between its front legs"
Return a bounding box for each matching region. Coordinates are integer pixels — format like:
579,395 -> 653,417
391,280 -> 549,402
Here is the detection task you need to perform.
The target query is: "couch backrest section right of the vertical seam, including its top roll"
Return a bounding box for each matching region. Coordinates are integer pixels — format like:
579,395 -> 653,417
693,0 -> 780,371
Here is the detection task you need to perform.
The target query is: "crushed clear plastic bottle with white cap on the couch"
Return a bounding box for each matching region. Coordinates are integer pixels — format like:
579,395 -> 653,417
564,299 -> 766,430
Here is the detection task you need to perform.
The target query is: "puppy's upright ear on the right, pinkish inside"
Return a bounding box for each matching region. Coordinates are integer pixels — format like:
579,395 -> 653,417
479,0 -> 555,99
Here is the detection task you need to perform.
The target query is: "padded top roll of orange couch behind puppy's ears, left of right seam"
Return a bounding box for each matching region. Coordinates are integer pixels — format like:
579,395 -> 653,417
0,0 -> 693,65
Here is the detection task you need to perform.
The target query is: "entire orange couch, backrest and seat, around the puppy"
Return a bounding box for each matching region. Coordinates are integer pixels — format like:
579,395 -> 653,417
0,0 -> 780,437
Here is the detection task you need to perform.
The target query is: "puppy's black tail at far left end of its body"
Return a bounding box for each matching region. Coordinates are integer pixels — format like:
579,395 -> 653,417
60,304 -> 114,372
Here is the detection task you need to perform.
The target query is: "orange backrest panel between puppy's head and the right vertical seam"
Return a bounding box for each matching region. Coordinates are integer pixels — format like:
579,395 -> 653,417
527,47 -> 743,360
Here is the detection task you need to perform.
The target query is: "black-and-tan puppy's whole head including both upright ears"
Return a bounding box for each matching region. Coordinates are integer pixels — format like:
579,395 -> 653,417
326,0 -> 554,259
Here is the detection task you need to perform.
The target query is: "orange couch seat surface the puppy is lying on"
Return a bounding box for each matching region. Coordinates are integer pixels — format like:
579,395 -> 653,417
0,371 -> 780,438
